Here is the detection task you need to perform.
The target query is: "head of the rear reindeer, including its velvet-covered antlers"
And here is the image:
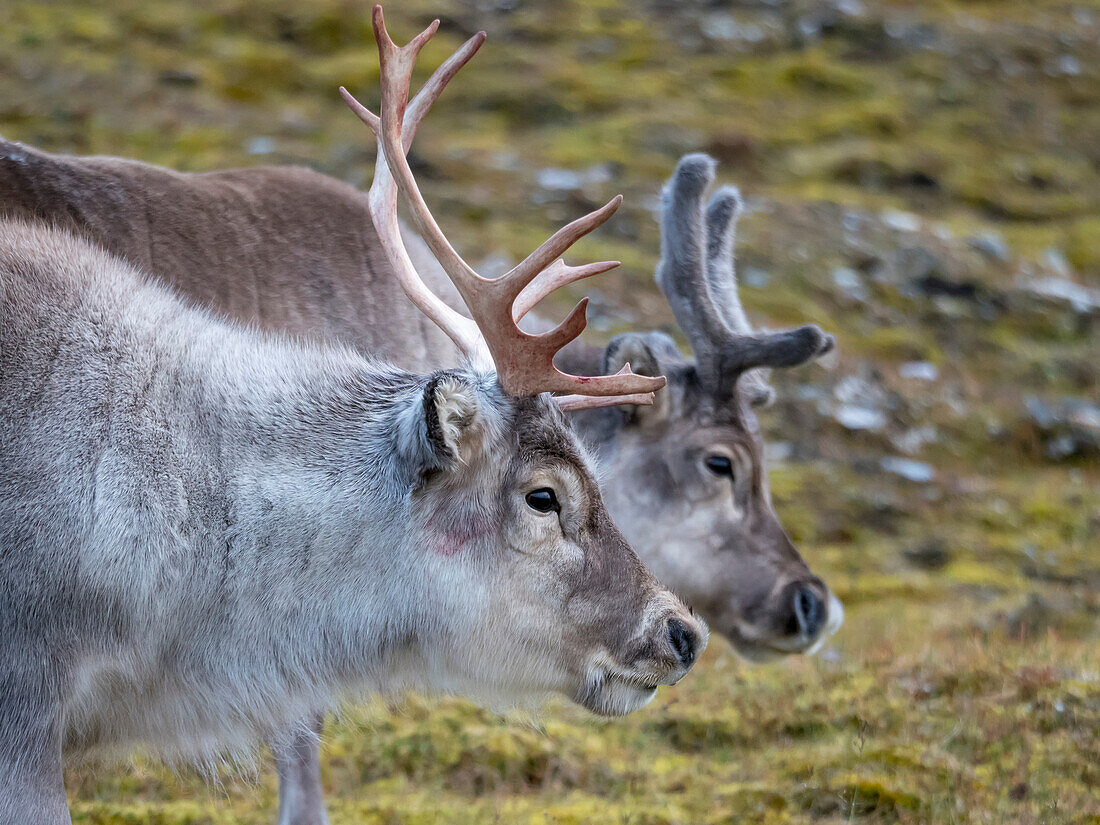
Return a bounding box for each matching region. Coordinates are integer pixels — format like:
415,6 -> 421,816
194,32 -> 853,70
572,155 -> 844,659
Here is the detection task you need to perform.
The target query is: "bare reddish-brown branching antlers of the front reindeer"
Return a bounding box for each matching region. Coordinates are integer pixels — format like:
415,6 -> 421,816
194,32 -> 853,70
340,6 -> 664,409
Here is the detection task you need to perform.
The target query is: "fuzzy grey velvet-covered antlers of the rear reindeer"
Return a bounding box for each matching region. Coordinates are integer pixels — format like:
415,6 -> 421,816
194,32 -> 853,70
657,154 -> 836,404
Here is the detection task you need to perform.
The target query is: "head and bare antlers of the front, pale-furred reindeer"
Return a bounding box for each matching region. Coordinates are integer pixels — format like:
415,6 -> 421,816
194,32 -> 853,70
341,7 -> 706,714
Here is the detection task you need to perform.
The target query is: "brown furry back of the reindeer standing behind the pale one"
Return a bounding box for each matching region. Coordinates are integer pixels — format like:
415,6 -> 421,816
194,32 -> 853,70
0,140 -> 457,369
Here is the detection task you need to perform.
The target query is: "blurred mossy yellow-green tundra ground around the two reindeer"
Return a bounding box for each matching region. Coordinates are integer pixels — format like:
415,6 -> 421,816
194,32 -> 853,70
0,0 -> 1100,825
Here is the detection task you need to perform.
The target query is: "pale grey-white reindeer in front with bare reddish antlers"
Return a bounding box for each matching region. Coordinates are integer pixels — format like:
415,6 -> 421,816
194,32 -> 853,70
0,13 -> 706,825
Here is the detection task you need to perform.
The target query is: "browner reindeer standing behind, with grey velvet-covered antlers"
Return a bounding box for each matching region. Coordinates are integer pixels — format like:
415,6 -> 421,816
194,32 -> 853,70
0,8 -> 844,823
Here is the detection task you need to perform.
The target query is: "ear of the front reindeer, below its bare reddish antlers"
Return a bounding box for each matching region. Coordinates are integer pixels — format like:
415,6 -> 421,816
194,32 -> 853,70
395,371 -> 492,486
